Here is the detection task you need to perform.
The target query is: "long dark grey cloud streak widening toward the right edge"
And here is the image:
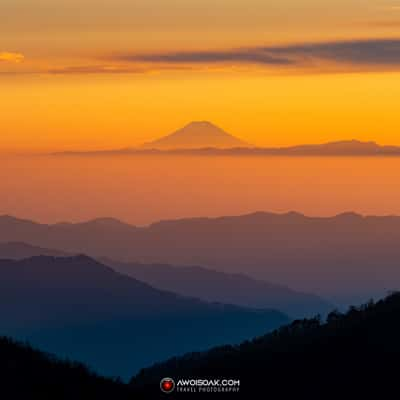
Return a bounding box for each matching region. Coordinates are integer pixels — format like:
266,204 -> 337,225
114,39 -> 400,67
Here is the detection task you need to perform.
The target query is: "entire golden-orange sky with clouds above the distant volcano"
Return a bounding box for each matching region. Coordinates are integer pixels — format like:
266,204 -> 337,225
0,0 -> 400,151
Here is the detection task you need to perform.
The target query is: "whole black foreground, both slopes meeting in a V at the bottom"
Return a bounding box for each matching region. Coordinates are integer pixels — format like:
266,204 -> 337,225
5,294 -> 400,400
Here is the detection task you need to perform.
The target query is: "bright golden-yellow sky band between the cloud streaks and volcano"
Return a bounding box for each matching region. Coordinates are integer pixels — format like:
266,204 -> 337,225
0,72 -> 400,151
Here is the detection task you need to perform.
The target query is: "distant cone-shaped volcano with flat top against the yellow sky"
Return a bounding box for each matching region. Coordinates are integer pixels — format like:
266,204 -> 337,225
143,121 -> 249,150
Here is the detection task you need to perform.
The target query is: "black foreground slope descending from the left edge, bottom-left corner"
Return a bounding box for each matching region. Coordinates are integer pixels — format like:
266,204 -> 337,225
0,337 -> 133,400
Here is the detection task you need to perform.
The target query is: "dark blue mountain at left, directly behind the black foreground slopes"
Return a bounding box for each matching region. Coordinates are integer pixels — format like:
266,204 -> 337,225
0,256 -> 289,377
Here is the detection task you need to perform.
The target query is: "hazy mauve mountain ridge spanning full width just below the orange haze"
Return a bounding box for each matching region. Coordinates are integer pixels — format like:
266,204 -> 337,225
0,212 -> 400,304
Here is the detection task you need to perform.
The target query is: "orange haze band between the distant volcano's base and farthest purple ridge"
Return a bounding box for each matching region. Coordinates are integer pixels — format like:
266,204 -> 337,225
0,156 -> 400,225
